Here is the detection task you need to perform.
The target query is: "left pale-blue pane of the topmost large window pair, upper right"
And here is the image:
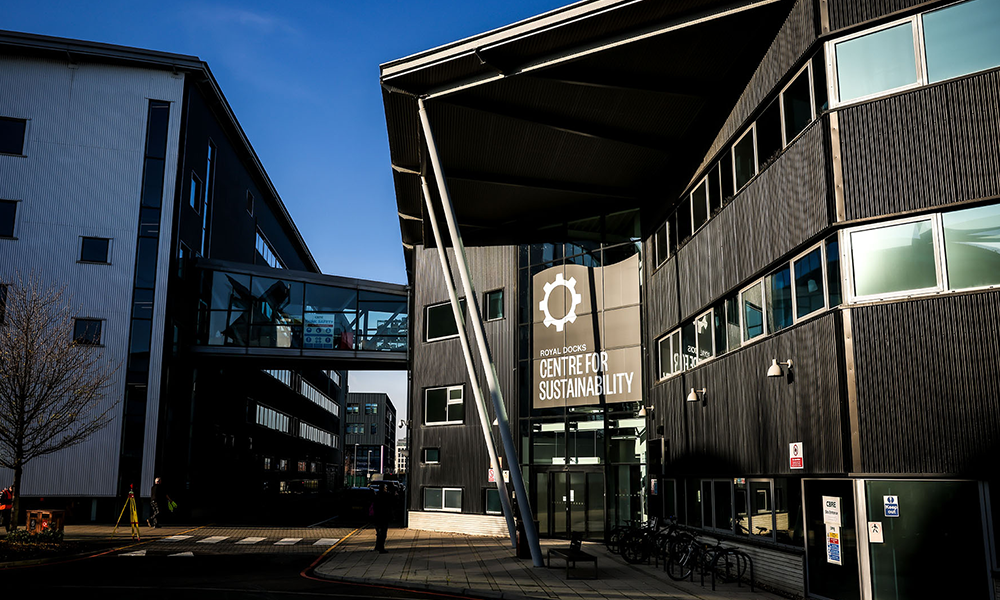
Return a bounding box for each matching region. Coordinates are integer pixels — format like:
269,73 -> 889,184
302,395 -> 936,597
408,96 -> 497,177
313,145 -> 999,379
833,20 -> 919,102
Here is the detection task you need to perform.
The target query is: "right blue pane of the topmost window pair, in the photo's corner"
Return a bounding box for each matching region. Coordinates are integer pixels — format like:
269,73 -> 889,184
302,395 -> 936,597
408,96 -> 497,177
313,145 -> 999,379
923,0 -> 1000,83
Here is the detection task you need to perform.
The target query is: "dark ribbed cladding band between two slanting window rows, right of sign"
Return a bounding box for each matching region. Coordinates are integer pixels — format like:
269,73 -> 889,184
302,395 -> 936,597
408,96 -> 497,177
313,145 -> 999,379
672,121 -> 830,324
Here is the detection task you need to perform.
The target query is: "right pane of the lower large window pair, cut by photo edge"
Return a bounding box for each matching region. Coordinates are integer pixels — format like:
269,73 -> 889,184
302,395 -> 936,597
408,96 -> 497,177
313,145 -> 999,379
942,204 -> 1000,290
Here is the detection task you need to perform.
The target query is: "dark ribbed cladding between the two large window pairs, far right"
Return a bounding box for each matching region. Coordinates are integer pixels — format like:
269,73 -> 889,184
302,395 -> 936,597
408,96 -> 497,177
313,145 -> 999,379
840,70 -> 1000,219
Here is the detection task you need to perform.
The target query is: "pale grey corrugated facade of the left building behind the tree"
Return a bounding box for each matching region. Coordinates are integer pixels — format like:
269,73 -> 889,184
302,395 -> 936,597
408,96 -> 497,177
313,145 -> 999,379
0,57 -> 184,496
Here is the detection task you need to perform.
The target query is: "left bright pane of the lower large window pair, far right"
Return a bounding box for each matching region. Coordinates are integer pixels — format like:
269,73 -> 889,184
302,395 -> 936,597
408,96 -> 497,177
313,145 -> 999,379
849,218 -> 938,297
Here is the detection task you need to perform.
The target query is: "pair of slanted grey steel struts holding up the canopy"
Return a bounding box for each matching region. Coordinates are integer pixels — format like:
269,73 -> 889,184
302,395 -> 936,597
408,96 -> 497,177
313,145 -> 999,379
417,98 -> 545,567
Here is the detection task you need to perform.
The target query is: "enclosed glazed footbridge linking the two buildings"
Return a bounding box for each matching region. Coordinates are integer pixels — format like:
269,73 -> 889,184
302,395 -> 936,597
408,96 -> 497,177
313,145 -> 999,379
190,260 -> 409,370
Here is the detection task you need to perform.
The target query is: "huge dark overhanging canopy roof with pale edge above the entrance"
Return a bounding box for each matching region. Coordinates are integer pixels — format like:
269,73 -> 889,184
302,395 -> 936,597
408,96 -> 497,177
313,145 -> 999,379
381,0 -> 792,271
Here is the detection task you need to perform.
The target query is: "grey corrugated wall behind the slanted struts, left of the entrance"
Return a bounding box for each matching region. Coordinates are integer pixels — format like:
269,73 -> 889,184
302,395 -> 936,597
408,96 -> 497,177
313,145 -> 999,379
410,246 -> 517,516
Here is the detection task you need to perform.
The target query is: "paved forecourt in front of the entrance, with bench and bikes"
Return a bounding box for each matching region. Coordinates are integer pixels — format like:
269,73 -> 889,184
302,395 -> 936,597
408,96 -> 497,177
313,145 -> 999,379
314,528 -> 781,600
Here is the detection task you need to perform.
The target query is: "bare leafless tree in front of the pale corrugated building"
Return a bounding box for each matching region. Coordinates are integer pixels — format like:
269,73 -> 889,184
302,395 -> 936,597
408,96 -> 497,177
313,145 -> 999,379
0,274 -> 118,527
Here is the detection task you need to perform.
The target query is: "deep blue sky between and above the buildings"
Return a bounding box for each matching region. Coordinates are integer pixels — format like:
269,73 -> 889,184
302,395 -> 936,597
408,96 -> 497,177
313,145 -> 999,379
0,0 -> 569,418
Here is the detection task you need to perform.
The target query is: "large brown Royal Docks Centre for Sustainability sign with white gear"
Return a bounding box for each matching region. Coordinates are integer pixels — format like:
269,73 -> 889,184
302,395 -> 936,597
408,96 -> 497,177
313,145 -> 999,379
532,255 -> 642,408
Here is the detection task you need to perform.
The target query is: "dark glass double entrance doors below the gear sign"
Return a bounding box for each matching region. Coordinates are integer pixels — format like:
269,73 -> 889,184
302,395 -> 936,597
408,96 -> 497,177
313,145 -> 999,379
535,470 -> 605,539
